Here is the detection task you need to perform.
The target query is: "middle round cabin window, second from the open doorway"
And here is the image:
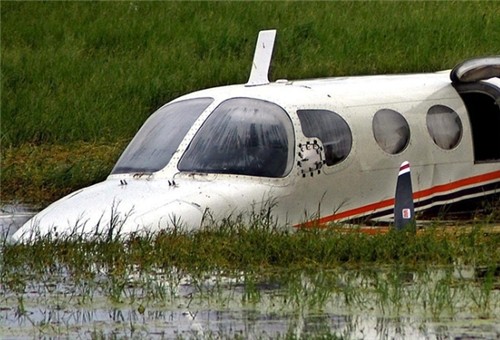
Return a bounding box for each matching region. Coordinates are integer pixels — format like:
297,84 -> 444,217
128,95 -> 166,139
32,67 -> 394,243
372,108 -> 411,155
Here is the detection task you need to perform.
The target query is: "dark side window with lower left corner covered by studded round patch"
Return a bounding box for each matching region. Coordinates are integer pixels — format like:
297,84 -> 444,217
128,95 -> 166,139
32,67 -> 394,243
297,109 -> 353,166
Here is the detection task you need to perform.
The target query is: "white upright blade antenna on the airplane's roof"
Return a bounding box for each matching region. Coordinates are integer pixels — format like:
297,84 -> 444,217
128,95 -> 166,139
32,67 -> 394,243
245,30 -> 276,86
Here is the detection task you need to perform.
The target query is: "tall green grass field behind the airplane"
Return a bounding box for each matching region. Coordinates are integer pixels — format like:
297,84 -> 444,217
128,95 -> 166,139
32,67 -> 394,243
0,1 -> 500,201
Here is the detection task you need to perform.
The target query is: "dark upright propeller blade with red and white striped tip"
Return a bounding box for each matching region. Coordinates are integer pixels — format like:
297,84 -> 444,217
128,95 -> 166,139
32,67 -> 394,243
394,161 -> 415,230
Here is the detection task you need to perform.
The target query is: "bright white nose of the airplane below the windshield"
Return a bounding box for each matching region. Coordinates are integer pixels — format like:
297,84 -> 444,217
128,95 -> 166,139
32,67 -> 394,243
12,180 -> 203,242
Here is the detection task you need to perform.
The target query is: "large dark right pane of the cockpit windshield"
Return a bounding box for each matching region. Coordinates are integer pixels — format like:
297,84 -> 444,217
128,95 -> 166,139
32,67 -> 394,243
178,98 -> 294,177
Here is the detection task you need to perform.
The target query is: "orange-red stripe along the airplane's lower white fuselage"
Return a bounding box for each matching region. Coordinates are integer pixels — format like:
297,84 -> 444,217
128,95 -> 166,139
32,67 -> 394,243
300,171 -> 500,227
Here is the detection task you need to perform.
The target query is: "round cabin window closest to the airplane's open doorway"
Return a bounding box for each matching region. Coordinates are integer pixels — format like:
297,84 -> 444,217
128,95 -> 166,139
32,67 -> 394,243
425,104 -> 463,150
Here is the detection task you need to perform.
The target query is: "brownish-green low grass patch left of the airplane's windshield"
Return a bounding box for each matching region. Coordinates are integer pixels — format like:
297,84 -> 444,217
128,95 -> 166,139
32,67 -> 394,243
2,142 -> 126,203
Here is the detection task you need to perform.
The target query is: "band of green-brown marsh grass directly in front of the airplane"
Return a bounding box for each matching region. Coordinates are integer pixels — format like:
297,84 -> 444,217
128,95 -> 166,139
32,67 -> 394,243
3,222 -> 500,276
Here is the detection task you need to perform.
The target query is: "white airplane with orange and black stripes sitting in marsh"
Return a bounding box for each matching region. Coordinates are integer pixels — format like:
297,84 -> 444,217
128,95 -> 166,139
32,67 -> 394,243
13,30 -> 500,241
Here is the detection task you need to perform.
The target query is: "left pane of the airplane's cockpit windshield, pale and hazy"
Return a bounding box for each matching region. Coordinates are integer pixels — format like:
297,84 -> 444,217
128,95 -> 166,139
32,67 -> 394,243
111,98 -> 213,174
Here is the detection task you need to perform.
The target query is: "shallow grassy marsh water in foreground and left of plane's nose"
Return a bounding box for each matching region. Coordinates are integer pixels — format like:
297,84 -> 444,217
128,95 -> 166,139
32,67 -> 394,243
0,206 -> 500,339
